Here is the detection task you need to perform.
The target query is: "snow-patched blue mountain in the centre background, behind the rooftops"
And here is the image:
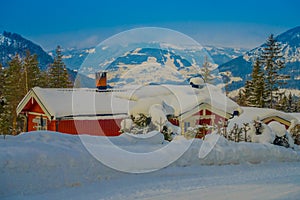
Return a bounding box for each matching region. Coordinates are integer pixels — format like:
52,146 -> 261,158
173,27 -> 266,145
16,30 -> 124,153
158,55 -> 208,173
72,42 -> 245,86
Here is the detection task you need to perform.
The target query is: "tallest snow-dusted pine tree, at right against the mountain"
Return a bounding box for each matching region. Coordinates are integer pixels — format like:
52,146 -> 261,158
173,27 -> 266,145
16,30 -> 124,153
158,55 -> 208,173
261,34 -> 288,108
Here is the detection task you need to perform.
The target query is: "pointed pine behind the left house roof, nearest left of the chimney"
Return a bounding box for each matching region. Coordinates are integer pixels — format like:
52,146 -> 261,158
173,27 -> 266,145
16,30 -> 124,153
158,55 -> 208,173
48,46 -> 72,88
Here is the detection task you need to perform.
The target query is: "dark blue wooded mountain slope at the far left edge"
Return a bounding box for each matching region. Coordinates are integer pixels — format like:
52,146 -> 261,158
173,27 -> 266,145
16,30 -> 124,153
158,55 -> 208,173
0,31 -> 53,70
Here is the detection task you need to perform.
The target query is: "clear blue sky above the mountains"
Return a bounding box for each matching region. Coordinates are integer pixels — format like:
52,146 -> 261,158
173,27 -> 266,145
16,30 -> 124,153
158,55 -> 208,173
0,0 -> 300,50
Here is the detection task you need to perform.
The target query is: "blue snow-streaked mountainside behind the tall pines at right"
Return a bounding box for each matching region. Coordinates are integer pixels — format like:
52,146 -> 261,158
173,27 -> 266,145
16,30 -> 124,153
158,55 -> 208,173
218,26 -> 300,91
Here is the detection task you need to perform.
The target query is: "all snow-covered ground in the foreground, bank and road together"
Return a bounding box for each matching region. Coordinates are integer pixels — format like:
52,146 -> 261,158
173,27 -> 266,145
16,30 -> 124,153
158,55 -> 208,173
0,132 -> 300,200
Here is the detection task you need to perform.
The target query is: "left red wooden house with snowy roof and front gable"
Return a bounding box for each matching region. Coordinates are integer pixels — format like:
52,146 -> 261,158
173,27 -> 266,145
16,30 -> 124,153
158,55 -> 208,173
17,87 -> 128,136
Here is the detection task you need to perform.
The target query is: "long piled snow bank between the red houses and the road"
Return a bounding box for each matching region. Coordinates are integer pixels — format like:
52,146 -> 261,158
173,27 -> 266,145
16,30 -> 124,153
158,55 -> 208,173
0,131 -> 300,198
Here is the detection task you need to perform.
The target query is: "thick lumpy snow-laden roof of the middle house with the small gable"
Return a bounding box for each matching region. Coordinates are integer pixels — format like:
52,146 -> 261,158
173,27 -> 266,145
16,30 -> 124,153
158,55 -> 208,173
117,84 -> 241,116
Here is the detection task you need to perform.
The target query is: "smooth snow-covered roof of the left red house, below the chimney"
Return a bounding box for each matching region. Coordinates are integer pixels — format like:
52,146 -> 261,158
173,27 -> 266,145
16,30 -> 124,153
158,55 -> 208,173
17,87 -> 129,119
